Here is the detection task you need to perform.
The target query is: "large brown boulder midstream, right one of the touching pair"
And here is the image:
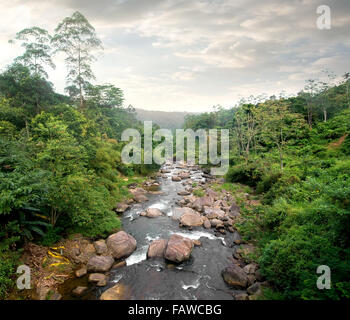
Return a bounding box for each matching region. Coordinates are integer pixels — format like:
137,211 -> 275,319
164,234 -> 193,263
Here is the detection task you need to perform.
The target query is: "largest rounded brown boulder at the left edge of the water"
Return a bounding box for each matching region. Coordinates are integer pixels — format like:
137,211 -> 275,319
107,231 -> 137,259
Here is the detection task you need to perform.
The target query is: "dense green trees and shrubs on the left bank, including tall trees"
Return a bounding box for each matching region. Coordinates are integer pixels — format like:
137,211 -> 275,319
0,12 -> 156,298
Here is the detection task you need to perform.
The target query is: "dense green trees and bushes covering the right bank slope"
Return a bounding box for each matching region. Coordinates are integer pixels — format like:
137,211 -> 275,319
185,79 -> 350,300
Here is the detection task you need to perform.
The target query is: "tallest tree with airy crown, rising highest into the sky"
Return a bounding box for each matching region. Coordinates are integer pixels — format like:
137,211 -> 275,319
52,11 -> 102,109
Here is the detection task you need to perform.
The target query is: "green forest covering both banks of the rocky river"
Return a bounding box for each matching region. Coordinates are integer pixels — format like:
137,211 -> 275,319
0,12 -> 350,300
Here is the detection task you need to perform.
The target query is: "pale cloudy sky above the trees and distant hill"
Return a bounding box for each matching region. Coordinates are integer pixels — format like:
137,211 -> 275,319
0,0 -> 350,112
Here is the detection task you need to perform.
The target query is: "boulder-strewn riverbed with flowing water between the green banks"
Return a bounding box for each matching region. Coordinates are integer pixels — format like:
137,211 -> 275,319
23,163 -> 268,300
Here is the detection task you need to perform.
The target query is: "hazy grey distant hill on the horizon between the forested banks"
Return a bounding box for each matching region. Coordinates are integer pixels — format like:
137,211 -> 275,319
135,109 -> 191,129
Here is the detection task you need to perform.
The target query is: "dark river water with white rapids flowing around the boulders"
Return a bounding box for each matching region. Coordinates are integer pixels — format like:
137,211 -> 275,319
95,166 -> 237,300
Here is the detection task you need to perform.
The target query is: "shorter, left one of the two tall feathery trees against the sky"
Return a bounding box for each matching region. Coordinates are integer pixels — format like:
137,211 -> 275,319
9,27 -> 55,78
